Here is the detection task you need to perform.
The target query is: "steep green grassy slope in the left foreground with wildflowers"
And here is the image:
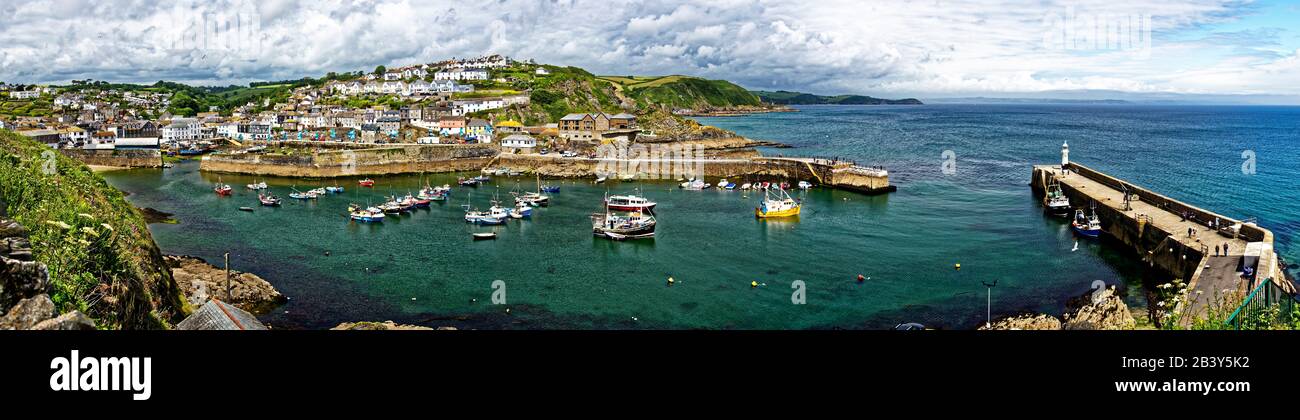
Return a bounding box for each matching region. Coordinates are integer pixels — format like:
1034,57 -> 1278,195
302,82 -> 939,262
0,130 -> 187,329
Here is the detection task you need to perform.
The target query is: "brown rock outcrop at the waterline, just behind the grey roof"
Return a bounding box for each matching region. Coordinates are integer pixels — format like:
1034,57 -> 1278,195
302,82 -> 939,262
164,255 -> 289,313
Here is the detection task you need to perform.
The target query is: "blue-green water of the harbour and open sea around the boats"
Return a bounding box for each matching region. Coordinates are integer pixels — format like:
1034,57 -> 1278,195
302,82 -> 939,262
105,105 -> 1300,329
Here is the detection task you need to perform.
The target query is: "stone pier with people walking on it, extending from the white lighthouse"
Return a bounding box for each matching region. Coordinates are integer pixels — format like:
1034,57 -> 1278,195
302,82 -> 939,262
1030,163 -> 1295,321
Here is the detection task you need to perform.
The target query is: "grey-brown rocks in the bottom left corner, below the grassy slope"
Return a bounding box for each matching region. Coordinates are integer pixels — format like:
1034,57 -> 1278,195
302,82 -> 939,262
0,218 -> 95,330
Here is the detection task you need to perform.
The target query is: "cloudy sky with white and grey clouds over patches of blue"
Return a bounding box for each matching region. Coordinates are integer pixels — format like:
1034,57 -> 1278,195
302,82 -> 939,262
0,0 -> 1300,103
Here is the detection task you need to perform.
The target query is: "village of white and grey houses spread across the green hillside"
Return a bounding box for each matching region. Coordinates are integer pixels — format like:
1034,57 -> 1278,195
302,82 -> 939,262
0,55 -> 757,155
